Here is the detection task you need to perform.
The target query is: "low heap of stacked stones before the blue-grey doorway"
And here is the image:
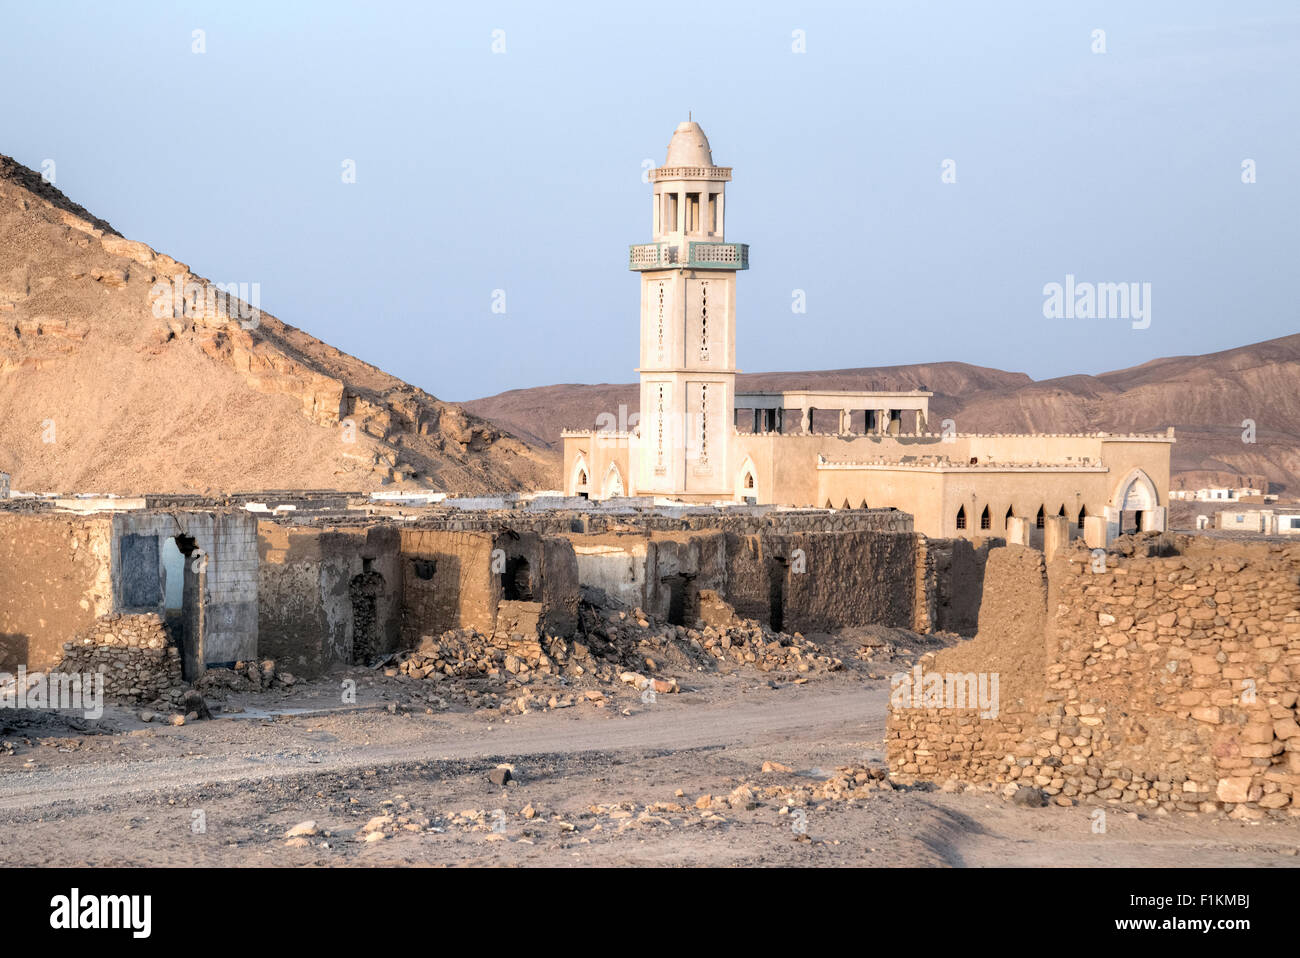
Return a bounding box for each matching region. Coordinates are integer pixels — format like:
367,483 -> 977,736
57,612 -> 185,703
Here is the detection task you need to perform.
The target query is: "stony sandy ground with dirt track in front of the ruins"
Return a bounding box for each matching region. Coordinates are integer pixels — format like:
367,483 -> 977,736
0,649 -> 1300,867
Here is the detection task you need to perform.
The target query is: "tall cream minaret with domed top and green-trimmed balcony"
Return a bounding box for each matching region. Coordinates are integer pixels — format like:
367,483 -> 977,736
628,121 -> 749,499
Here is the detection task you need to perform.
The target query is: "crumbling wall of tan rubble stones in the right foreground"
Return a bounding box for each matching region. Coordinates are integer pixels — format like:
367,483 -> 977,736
887,541 -> 1300,818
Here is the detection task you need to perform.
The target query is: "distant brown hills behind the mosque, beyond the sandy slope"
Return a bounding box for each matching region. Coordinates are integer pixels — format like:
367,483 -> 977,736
465,334 -> 1300,495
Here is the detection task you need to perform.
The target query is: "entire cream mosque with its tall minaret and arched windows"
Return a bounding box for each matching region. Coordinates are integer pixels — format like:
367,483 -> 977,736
563,122 -> 1174,545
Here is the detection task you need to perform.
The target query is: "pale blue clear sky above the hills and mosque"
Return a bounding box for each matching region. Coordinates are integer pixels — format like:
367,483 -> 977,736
0,0 -> 1300,400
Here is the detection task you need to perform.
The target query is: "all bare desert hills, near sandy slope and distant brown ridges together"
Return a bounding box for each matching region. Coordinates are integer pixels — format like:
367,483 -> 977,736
0,156 -> 1300,495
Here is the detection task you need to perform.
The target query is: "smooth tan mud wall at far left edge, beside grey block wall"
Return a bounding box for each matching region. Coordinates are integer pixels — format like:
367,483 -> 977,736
0,510 -> 113,672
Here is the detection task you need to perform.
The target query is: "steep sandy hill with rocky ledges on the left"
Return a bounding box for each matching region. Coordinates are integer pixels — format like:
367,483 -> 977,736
0,156 -> 555,493
